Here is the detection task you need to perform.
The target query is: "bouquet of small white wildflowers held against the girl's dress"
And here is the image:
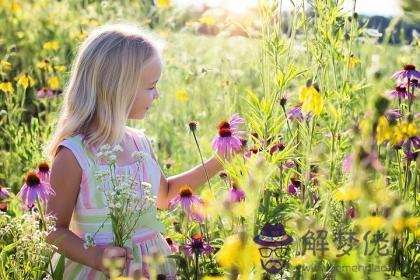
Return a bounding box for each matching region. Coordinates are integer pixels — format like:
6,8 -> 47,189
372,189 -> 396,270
85,145 -> 156,247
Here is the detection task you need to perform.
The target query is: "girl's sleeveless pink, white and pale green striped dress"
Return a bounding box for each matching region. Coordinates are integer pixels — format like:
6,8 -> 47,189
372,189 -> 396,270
54,129 -> 176,280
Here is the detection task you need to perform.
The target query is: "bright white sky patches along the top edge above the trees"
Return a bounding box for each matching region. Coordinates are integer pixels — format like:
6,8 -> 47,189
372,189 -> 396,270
174,0 -> 402,16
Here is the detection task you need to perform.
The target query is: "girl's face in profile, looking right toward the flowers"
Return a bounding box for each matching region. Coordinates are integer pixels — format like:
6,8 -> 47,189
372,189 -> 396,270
128,56 -> 162,120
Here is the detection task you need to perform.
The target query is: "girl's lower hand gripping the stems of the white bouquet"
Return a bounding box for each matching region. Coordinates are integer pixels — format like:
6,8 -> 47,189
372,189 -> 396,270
96,245 -> 133,276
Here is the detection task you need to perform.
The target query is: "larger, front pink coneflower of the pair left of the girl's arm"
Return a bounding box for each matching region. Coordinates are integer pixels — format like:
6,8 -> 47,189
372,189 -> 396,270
18,171 -> 55,208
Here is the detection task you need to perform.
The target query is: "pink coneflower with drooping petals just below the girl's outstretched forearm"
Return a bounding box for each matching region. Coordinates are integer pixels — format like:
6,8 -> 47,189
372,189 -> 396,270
168,186 -> 204,223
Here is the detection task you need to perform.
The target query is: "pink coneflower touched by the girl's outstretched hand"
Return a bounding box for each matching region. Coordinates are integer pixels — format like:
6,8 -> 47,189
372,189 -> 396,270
212,114 -> 245,158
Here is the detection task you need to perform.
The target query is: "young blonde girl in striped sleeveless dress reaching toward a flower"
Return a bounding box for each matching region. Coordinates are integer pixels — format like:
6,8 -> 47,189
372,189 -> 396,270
47,24 -> 222,279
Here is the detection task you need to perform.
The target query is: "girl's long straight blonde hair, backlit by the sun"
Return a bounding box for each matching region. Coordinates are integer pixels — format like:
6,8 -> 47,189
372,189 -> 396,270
47,24 -> 159,160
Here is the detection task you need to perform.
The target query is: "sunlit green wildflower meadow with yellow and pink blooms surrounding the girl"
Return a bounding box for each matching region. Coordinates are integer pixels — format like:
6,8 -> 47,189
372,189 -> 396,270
0,0 -> 420,280
